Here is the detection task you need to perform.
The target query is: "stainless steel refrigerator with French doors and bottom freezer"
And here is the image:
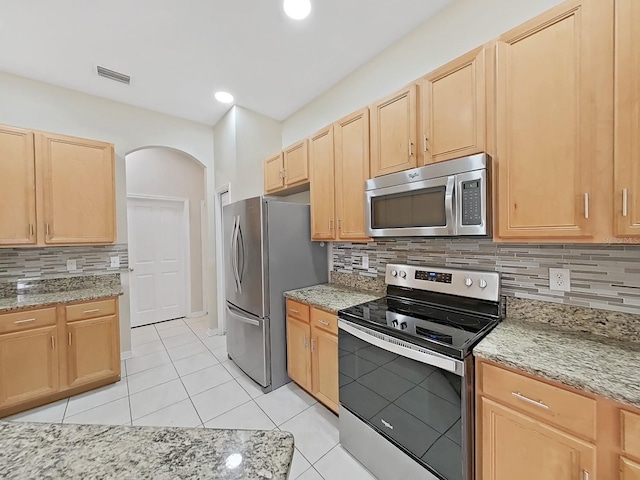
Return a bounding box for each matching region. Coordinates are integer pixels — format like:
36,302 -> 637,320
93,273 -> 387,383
223,197 -> 328,392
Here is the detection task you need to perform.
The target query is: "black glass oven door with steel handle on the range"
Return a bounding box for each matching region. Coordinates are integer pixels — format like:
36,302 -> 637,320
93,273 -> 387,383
338,319 -> 473,480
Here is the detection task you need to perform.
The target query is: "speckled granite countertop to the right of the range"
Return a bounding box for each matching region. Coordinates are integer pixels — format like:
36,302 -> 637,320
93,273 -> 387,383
473,318 -> 640,408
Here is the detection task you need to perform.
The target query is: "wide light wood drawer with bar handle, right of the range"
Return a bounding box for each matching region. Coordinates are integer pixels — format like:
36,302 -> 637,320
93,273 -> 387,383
481,363 -> 596,439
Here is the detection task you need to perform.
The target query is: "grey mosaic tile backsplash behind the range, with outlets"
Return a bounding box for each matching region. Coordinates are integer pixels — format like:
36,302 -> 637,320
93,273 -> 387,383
332,238 -> 640,314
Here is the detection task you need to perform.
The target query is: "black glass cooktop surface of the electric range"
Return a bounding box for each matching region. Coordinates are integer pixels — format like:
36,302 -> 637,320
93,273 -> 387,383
338,296 -> 499,359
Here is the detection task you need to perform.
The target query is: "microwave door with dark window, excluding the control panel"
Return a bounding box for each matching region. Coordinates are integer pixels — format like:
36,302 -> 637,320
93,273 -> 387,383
365,175 -> 457,237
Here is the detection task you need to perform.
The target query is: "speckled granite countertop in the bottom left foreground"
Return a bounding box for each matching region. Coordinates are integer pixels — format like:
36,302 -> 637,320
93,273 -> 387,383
0,421 -> 294,480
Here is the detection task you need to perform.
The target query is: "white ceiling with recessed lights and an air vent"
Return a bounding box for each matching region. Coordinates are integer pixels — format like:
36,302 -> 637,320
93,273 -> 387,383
0,0 -> 453,125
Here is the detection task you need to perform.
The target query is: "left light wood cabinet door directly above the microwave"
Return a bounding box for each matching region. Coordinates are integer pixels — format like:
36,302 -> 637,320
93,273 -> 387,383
371,85 -> 418,177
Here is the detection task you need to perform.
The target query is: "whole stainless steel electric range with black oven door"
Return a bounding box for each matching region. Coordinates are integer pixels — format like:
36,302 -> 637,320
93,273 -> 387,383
338,264 -> 501,480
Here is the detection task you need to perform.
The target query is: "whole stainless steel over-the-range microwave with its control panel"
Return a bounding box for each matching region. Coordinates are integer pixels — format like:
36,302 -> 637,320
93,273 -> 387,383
365,153 -> 491,237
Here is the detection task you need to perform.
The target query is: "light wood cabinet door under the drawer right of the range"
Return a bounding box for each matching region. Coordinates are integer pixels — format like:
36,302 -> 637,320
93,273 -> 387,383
479,397 -> 596,480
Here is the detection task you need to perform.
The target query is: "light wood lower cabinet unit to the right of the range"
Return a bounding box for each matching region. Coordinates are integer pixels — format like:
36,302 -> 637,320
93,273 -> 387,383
476,360 -> 640,480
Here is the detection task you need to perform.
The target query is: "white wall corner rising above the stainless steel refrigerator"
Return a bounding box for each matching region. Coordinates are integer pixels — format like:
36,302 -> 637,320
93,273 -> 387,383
214,106 -> 282,202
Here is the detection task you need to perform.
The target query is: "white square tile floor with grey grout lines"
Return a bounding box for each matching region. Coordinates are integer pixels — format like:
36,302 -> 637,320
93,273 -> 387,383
5,317 -> 375,480
